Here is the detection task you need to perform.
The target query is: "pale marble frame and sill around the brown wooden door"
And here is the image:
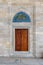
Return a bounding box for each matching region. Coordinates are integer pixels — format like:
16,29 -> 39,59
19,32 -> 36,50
11,26 -> 34,57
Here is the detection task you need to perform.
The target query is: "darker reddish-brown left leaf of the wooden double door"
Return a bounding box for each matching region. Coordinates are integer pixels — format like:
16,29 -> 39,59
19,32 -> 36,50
15,29 -> 21,51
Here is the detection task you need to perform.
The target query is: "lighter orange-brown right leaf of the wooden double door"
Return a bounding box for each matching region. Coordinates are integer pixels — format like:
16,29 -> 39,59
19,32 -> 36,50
21,29 -> 28,51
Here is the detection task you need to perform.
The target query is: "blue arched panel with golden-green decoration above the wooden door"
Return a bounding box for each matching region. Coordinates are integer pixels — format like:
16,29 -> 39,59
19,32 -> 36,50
13,11 -> 31,22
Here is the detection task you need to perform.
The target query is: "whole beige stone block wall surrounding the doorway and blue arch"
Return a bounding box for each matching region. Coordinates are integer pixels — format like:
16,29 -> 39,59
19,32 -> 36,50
0,0 -> 43,57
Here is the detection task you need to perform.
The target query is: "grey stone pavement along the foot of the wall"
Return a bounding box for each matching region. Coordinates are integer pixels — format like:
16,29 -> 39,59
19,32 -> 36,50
0,57 -> 43,65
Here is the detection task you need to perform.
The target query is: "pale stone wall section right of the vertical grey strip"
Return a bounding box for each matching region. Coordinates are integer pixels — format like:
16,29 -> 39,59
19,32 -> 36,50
35,2 -> 43,56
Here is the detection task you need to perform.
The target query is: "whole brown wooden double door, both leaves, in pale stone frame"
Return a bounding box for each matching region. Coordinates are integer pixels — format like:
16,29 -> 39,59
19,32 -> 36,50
15,29 -> 28,51
